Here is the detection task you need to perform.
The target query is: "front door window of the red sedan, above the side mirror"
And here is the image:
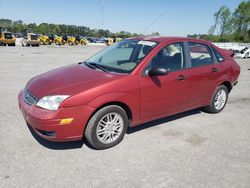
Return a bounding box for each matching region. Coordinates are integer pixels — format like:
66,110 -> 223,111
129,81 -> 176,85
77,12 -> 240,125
147,43 -> 185,72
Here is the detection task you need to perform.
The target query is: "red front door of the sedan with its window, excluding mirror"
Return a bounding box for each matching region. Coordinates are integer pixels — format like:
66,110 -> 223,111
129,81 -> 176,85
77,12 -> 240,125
140,43 -> 188,120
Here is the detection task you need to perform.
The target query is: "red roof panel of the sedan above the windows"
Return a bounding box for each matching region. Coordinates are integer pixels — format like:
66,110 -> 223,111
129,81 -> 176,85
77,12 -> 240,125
130,36 -> 211,44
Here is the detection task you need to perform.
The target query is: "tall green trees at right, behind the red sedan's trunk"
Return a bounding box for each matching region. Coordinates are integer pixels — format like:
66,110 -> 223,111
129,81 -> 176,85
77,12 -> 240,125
188,0 -> 250,42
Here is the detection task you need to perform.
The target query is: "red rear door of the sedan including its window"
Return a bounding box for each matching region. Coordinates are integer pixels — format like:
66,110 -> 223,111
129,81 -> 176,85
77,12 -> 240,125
187,42 -> 225,107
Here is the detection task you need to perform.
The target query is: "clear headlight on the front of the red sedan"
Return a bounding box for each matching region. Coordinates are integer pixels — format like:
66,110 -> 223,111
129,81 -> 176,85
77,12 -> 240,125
36,95 -> 69,110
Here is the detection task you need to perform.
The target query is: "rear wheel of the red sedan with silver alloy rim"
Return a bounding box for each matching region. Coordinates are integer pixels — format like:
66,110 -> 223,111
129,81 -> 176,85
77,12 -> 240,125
204,85 -> 229,114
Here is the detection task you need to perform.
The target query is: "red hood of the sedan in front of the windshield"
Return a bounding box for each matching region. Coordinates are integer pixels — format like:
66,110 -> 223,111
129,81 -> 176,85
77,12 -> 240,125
26,64 -> 125,98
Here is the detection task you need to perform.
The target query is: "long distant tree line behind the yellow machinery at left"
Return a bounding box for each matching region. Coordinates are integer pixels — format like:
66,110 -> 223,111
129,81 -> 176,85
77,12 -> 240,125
0,19 -> 139,38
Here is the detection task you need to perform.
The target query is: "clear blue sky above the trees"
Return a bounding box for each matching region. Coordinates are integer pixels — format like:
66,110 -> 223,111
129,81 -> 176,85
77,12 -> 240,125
0,0 -> 243,36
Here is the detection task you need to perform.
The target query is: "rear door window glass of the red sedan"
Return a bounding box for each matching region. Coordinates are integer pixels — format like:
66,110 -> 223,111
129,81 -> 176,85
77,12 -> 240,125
188,42 -> 213,67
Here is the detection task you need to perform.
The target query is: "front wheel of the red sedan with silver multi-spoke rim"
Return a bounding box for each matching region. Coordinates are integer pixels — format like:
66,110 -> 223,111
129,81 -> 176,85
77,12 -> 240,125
84,105 -> 129,150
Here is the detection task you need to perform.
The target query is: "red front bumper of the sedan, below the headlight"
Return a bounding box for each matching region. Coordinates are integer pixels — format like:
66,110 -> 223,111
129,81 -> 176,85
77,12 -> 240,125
18,91 -> 94,142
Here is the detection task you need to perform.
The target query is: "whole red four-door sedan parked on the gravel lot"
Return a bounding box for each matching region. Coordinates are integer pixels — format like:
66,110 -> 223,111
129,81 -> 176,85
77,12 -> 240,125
18,37 -> 240,149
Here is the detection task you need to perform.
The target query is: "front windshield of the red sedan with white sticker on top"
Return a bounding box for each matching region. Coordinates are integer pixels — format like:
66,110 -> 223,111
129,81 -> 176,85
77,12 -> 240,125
86,40 -> 157,73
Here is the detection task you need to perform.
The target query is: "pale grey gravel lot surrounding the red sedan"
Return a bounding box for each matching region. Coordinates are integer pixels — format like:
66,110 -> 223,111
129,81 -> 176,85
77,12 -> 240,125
0,46 -> 250,188
